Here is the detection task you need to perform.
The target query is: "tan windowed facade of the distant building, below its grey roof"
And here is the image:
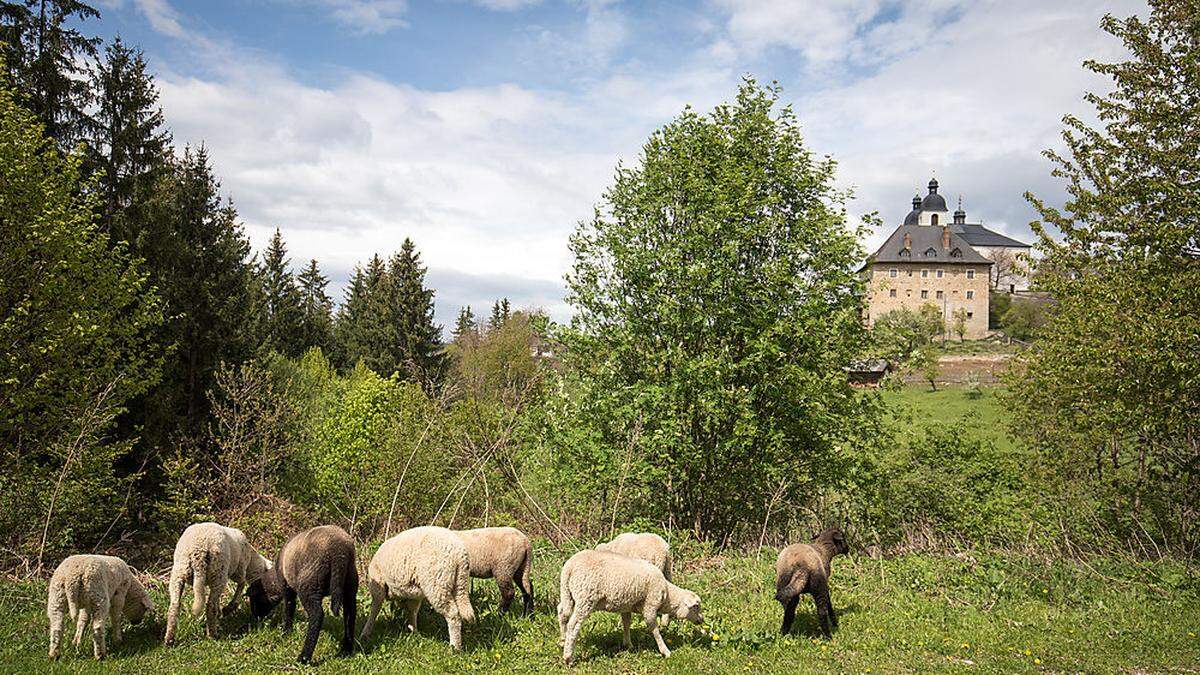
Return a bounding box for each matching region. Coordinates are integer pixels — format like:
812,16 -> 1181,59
866,262 -> 989,340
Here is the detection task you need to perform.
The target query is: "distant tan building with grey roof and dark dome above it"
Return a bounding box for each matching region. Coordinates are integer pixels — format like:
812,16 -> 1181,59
859,180 -> 994,340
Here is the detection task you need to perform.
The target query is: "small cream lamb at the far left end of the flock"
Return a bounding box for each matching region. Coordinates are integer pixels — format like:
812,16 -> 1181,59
46,555 -> 151,659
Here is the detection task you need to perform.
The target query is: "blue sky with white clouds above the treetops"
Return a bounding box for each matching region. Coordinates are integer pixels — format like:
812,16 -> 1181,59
97,0 -> 1146,323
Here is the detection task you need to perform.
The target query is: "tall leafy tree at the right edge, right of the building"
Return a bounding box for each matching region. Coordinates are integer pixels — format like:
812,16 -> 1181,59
1010,0 -> 1200,550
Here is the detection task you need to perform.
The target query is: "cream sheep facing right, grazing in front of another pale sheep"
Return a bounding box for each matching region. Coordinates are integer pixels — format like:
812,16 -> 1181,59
558,550 -> 704,664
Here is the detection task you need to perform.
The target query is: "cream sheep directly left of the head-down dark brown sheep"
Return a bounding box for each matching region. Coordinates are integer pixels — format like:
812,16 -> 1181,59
163,522 -> 271,645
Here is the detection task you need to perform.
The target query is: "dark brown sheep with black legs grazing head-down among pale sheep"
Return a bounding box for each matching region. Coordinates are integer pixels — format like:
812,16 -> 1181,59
246,525 -> 359,663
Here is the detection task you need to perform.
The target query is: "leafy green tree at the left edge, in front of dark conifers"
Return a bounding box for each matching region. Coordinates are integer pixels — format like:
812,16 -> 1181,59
0,77 -> 163,561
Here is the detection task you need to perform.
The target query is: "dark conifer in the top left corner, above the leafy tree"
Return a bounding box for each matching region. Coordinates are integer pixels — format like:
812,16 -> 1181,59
0,0 -> 100,142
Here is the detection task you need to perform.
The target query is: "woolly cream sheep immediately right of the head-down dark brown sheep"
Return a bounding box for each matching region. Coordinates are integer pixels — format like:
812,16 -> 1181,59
360,526 -> 475,650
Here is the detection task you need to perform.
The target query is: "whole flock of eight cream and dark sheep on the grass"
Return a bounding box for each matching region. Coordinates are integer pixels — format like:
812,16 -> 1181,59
46,522 -> 848,664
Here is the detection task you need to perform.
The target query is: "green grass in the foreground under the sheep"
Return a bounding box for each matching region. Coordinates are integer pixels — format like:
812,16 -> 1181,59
0,546 -> 1200,673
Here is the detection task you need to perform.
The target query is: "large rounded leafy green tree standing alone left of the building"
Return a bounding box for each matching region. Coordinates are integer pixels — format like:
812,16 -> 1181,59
556,80 -> 875,538
